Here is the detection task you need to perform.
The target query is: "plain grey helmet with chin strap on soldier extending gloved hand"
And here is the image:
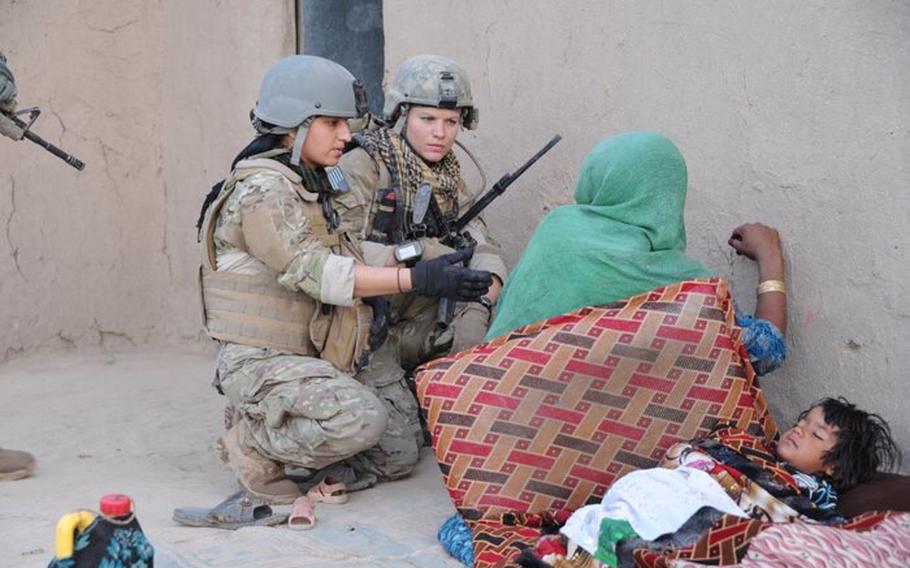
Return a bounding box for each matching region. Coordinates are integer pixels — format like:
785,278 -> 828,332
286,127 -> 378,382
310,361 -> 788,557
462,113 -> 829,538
250,55 -> 367,164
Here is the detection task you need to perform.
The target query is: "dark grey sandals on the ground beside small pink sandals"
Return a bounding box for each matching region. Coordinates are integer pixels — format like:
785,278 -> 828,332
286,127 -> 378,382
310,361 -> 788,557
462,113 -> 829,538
174,491 -> 288,530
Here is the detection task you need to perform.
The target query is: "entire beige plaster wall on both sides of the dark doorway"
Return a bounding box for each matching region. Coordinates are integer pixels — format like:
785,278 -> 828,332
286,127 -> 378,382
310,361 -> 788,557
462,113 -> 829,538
0,0 -> 910,466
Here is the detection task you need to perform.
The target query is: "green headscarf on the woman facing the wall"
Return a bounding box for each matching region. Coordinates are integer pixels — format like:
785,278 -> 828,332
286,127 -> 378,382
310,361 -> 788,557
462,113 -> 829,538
486,132 -> 711,340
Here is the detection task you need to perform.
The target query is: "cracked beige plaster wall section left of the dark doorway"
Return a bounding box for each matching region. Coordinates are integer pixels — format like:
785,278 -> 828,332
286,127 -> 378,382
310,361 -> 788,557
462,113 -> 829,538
0,0 -> 295,361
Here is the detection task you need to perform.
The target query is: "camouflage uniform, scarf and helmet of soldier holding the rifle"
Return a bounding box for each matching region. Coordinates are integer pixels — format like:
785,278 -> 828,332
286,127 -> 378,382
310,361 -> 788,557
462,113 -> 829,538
338,55 -> 506,369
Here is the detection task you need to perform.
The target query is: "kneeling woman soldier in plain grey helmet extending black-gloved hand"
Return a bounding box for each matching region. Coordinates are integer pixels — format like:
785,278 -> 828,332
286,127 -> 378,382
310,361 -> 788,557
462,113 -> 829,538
199,55 -> 491,503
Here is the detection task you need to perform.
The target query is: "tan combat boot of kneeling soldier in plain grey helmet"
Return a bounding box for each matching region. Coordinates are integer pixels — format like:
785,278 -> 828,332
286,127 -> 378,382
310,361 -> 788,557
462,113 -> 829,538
219,423 -> 301,505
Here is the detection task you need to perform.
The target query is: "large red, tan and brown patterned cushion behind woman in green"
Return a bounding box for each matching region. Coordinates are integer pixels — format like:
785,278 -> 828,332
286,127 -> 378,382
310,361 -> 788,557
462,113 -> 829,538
416,279 -> 776,566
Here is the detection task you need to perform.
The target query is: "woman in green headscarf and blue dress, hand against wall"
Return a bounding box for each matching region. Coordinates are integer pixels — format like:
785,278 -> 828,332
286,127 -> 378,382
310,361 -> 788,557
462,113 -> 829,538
439,132 -> 787,564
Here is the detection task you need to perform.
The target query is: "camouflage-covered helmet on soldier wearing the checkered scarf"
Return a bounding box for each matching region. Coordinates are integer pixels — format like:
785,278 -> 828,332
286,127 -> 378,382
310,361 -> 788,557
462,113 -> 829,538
383,55 -> 478,130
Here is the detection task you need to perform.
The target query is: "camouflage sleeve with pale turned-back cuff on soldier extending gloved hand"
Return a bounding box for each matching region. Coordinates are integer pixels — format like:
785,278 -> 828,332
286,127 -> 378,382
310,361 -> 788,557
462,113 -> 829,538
235,172 -> 354,306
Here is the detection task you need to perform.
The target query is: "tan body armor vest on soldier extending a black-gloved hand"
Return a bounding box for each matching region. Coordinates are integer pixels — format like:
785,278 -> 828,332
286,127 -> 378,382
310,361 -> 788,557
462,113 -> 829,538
199,158 -> 372,373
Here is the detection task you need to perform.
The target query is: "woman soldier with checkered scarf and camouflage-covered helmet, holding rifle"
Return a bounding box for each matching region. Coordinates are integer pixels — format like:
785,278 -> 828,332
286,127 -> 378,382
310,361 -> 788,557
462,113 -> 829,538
338,55 -> 506,377
